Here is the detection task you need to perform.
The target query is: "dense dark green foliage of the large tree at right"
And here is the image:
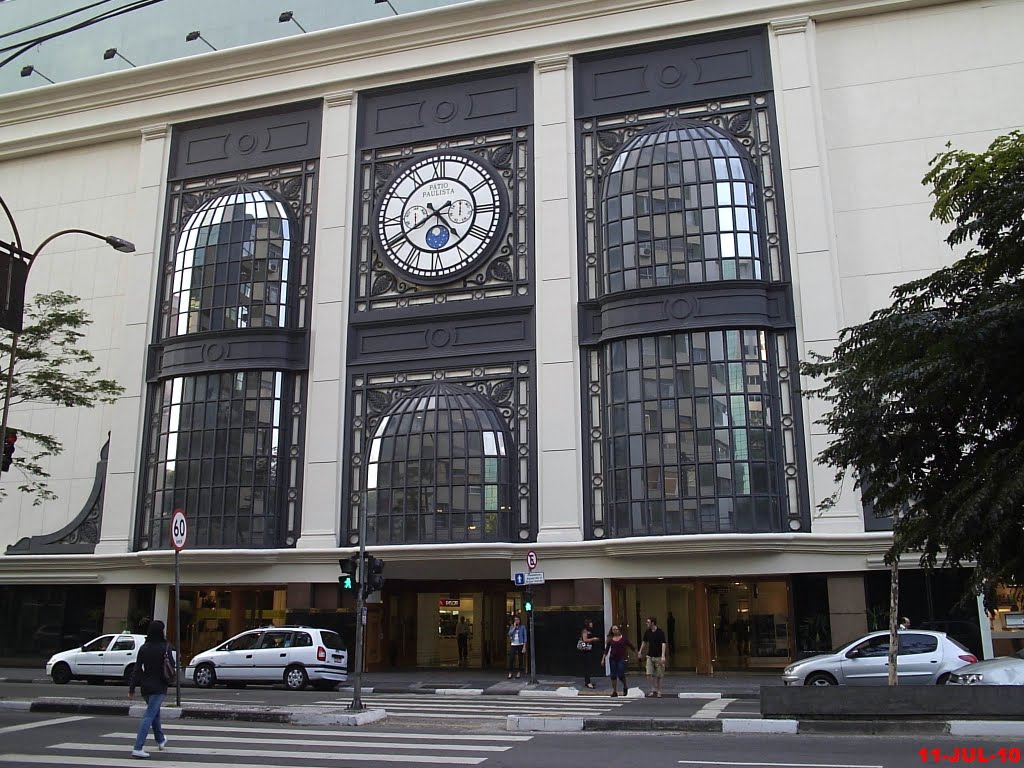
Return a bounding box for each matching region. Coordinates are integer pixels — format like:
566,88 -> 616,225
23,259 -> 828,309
801,131 -> 1024,602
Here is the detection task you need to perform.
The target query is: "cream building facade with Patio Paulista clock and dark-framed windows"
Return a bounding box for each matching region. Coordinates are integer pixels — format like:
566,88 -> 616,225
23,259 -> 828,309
0,0 -> 1024,673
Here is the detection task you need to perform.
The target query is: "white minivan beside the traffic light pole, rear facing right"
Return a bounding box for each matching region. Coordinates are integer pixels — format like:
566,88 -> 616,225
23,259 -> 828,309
185,627 -> 348,690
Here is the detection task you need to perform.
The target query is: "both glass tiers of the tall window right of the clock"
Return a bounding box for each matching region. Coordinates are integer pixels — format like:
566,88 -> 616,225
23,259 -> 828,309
592,118 -> 786,537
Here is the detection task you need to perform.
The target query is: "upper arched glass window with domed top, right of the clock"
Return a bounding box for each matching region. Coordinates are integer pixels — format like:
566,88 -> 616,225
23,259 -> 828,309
601,120 -> 763,293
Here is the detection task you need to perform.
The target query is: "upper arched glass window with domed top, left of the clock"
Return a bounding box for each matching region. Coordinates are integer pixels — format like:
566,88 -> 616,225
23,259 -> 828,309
164,185 -> 297,337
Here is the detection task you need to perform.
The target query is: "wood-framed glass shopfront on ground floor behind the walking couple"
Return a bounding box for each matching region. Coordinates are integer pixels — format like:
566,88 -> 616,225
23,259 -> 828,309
611,579 -> 794,674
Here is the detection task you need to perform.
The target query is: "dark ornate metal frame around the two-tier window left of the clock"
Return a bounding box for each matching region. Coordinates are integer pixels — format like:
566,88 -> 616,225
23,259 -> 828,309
135,160 -> 318,550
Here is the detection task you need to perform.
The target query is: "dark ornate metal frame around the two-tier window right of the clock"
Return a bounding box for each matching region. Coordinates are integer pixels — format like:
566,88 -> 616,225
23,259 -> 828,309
577,97 -> 810,539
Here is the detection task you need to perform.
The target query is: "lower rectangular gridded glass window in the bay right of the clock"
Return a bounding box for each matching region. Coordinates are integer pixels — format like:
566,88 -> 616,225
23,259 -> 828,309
604,330 -> 781,537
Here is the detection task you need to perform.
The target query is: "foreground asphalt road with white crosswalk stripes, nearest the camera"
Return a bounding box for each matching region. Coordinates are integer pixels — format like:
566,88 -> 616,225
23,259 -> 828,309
0,712 -> 1021,768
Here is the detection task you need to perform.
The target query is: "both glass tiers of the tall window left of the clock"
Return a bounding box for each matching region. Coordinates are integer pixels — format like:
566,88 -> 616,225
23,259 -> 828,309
139,185 -> 297,549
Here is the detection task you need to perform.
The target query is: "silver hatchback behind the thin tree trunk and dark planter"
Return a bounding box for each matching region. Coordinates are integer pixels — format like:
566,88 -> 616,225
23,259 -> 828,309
782,630 -> 978,685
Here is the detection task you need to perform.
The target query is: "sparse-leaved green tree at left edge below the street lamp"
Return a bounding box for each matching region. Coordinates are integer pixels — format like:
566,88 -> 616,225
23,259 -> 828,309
0,291 -> 124,505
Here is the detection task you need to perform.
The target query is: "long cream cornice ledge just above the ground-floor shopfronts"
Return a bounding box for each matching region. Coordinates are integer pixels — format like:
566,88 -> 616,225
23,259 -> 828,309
0,531 -> 897,584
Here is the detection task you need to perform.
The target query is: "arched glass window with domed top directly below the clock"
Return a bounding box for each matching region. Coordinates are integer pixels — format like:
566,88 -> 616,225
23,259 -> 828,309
366,383 -> 516,544
